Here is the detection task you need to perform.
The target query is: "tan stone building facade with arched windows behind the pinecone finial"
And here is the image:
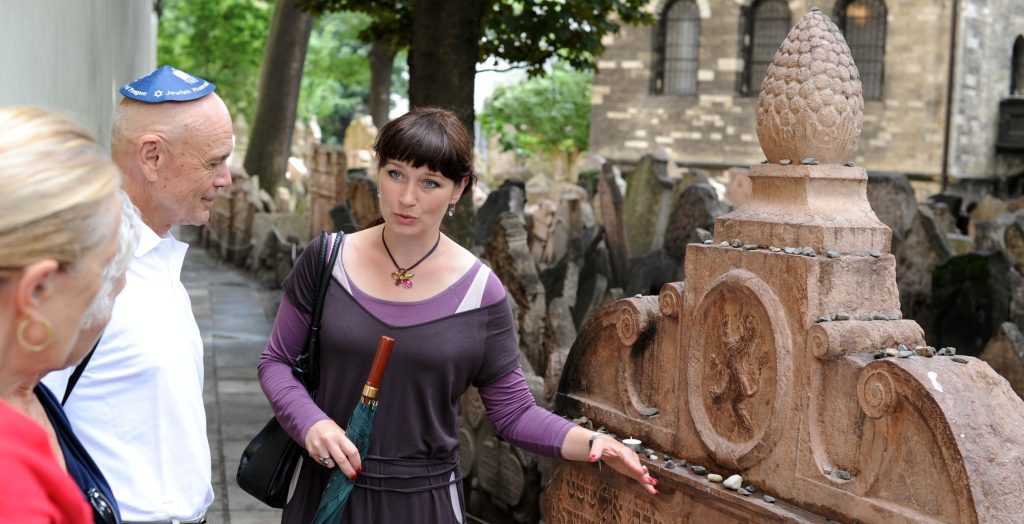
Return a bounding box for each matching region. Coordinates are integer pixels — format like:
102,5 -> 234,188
590,0 -> 1024,182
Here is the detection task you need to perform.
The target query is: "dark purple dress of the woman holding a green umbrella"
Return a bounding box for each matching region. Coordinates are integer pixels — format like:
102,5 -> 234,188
261,237 -> 524,524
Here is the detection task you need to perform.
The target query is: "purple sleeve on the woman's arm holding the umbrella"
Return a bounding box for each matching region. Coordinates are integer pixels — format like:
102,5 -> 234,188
259,294 -> 329,445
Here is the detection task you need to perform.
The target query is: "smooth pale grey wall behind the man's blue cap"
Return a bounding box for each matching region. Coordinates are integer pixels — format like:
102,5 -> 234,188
0,0 -> 159,147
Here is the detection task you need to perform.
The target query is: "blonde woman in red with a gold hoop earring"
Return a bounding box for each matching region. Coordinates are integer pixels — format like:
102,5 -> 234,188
0,107 -> 121,523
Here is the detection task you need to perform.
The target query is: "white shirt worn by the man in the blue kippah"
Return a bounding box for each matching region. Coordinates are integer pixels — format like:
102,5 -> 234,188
44,215 -> 213,521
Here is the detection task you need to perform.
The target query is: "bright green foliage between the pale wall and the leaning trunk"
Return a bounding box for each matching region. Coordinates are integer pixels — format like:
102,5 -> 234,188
157,0 -> 273,122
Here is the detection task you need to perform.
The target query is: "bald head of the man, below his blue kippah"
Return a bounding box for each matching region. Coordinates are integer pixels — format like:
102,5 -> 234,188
111,93 -> 233,234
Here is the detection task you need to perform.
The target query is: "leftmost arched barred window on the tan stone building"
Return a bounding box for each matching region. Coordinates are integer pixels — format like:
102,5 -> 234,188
653,0 -> 700,94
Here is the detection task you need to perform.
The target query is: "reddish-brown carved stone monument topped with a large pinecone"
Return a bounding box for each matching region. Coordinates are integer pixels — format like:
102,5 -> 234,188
543,8 -> 1024,524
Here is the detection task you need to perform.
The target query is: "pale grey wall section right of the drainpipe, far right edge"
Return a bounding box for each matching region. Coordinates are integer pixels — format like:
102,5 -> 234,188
950,0 -> 1024,176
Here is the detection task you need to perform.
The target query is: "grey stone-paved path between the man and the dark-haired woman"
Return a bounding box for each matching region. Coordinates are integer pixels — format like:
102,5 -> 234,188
178,233 -> 281,524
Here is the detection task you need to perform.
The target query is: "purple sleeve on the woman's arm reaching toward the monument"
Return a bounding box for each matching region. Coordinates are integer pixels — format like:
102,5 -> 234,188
480,367 -> 574,459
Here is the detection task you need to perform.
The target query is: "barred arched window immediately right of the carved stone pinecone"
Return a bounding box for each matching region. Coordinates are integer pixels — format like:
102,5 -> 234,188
836,0 -> 887,100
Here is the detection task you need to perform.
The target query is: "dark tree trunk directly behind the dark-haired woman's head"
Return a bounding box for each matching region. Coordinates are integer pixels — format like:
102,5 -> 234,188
409,0 -> 493,249
